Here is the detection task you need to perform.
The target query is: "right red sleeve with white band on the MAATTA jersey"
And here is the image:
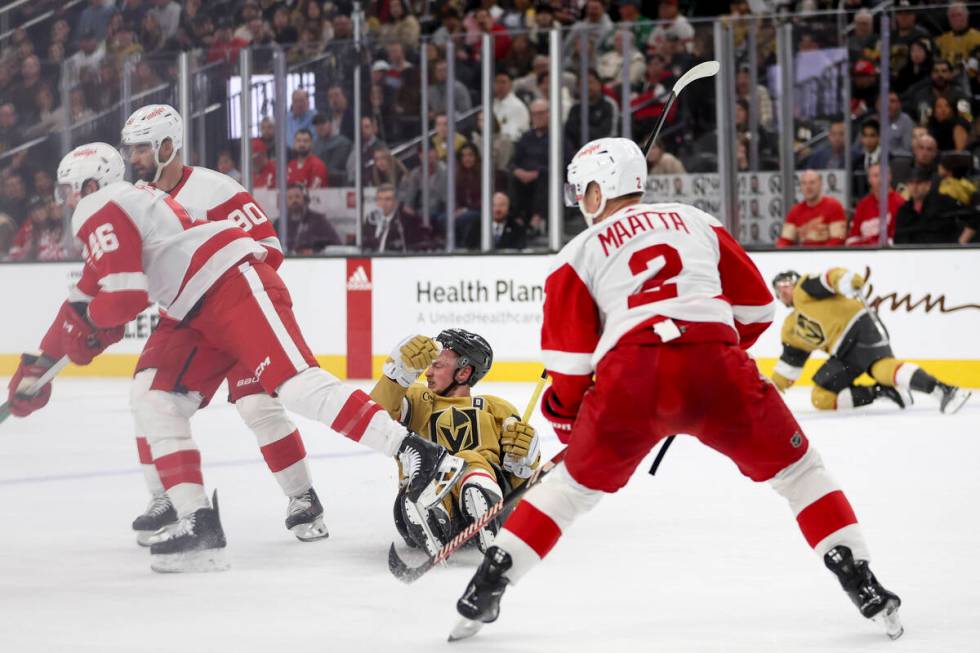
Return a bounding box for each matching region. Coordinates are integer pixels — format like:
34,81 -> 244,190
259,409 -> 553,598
713,227 -> 776,349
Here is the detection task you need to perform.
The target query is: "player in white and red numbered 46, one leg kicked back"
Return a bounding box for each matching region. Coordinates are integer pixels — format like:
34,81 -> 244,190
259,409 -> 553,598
3,143 -> 463,571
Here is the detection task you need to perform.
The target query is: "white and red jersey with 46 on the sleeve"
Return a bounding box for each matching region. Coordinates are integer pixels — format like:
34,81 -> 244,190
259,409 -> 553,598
69,181 -> 267,327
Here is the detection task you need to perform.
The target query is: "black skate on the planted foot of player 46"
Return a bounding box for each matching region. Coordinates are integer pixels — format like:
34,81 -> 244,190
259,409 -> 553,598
150,492 -> 228,573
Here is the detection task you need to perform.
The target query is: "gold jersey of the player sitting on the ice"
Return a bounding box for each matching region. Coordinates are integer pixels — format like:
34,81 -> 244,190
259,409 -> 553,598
371,377 -> 523,492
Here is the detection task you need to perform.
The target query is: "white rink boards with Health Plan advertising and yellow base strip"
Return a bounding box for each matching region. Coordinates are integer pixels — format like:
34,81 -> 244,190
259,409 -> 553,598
0,250 -> 980,386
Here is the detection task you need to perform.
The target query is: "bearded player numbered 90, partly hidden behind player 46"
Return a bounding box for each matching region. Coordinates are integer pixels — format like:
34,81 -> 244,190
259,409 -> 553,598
122,104 -> 327,546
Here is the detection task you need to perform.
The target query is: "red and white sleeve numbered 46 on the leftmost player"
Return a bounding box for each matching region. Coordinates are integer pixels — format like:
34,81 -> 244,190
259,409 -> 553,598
69,202 -> 150,328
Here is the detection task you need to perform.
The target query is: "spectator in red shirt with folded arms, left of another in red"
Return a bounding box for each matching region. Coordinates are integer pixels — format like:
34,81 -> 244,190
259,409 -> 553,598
776,170 -> 847,247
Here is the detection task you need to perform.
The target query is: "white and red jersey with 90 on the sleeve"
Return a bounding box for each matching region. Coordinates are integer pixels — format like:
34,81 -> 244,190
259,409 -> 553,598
151,166 -> 283,268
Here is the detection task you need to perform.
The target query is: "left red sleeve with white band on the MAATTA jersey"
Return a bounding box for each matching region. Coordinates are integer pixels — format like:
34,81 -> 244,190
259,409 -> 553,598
541,262 -> 602,415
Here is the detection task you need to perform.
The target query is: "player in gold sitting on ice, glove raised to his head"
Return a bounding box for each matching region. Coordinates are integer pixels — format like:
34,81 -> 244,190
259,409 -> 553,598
371,329 -> 540,555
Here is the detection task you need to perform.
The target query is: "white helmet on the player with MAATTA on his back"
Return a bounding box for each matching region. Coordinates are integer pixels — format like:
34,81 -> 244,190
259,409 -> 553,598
565,138 -> 647,225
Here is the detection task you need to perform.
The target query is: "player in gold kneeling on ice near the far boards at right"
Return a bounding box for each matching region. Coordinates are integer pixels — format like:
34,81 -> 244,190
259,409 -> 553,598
772,268 -> 971,414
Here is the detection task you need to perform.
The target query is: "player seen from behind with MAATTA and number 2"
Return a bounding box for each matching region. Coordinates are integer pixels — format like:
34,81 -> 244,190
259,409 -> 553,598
450,138 -> 901,639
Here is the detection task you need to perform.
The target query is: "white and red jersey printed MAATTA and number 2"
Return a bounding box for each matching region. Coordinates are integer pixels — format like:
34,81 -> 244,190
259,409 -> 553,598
541,203 -> 775,388
